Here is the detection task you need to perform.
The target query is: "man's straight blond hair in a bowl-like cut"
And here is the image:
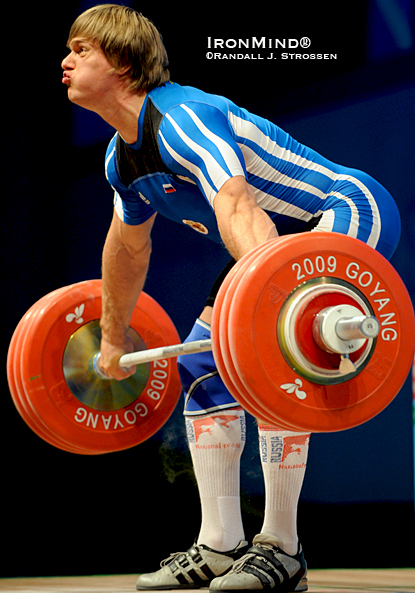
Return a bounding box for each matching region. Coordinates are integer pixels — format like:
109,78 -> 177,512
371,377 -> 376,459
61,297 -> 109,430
68,4 -> 170,92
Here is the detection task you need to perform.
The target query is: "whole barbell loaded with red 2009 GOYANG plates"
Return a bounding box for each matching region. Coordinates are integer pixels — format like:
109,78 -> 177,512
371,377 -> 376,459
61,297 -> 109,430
7,233 -> 415,455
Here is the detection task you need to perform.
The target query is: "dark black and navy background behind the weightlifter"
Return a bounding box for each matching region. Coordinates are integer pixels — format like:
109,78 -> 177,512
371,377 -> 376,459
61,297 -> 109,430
0,0 -> 415,577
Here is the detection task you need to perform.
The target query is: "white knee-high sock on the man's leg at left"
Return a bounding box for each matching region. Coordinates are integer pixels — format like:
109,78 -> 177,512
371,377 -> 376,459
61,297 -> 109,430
186,407 -> 246,552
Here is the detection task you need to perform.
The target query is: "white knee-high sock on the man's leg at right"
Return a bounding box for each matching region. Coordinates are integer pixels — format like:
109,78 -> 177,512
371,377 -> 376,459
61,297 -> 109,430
258,425 -> 310,555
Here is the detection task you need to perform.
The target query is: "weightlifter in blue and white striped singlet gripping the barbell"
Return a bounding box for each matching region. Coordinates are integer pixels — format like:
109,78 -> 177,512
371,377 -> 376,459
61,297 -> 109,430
62,4 -> 400,593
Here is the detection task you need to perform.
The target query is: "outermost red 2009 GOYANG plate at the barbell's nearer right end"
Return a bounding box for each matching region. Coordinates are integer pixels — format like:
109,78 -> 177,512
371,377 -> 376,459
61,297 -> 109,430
229,232 -> 415,432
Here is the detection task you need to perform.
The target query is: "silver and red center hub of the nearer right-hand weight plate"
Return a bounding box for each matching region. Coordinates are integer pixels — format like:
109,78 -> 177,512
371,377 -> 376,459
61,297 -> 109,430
277,277 -> 376,385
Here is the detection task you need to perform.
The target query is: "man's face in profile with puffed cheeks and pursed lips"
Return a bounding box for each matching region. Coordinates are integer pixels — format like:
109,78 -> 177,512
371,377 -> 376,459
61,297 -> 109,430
62,37 -> 120,112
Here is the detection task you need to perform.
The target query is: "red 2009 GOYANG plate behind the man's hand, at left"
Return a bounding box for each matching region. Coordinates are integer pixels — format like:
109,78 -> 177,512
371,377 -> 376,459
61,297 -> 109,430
21,280 -> 180,454
